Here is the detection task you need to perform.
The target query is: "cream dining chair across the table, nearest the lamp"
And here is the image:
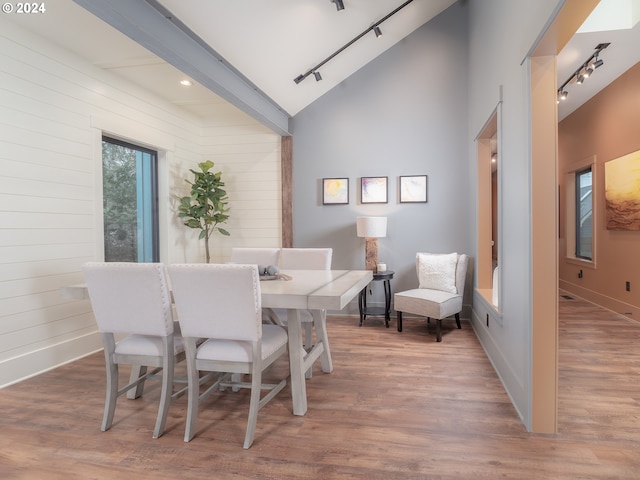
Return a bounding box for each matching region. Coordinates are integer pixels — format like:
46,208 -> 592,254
272,248 -> 333,354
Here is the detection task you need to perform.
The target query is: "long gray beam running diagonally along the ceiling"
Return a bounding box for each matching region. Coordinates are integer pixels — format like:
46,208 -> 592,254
73,0 -> 290,136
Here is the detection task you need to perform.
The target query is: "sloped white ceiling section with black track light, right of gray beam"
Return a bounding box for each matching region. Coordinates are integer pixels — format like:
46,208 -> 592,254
159,0 -> 456,116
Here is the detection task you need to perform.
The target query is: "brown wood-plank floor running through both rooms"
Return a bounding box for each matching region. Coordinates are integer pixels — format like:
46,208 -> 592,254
0,297 -> 640,480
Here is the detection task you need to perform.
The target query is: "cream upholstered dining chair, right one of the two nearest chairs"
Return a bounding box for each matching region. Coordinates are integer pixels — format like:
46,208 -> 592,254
169,264 -> 288,448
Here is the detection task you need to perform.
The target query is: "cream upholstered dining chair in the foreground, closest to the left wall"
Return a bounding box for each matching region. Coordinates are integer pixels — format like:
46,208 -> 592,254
83,262 -> 184,438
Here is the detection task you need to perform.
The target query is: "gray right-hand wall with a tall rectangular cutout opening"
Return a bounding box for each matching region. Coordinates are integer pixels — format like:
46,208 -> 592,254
467,0 -> 564,429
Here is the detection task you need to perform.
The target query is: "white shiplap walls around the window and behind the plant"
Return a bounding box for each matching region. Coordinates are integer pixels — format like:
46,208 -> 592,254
0,18 -> 280,388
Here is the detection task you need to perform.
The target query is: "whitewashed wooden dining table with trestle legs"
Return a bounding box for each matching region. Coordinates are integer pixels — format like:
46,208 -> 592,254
61,270 -> 373,415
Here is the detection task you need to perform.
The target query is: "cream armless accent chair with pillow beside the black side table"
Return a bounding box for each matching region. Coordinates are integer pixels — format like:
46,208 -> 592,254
393,253 -> 469,342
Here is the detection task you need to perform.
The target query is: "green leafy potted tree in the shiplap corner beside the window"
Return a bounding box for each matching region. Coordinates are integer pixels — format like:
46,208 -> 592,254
178,160 -> 230,263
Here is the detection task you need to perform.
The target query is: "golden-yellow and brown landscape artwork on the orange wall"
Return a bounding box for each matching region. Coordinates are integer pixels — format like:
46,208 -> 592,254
604,150 -> 640,230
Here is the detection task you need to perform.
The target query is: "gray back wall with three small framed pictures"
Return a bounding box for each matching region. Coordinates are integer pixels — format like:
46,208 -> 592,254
291,4 -> 475,316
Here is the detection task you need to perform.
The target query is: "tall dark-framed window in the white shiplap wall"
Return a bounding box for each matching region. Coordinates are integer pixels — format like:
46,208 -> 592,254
102,137 -> 159,262
